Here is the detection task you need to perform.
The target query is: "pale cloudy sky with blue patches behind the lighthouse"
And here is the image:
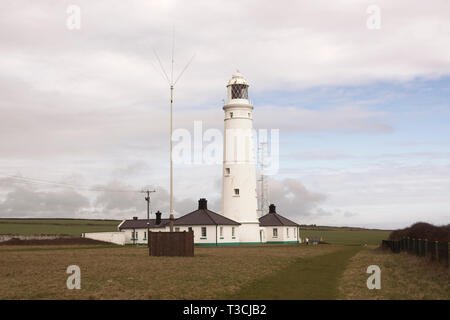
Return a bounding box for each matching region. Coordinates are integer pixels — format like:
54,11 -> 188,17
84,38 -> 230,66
0,0 -> 450,229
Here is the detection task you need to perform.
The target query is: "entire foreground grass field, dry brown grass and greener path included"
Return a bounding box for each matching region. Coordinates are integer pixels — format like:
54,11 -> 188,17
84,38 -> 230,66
0,245 -> 450,299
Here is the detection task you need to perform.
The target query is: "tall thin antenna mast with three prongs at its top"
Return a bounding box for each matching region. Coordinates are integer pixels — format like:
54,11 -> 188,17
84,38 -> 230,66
153,28 -> 195,232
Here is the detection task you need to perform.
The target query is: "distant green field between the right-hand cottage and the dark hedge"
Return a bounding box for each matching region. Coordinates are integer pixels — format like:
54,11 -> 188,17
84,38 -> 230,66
300,229 -> 391,245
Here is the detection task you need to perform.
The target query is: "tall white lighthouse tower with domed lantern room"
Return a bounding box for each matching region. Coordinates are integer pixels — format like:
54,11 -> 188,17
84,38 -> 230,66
222,71 -> 260,243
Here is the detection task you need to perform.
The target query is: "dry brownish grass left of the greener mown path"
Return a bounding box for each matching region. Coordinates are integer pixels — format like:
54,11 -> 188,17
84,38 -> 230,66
0,245 -> 340,299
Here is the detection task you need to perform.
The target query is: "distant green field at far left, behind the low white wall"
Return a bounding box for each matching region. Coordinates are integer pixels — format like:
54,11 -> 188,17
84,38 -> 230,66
0,219 -> 120,235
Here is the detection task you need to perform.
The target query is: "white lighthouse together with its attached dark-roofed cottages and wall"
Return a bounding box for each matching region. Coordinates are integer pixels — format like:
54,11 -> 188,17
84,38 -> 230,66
84,72 -> 299,246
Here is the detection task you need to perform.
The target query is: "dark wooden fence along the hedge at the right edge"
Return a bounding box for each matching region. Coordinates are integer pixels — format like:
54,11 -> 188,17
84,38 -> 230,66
381,238 -> 450,272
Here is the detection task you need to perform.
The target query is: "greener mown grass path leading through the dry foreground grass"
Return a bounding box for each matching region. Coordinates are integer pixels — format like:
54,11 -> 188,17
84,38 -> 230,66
229,247 -> 362,300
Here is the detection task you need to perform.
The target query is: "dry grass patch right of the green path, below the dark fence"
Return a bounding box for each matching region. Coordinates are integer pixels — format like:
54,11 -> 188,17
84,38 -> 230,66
339,249 -> 450,300
